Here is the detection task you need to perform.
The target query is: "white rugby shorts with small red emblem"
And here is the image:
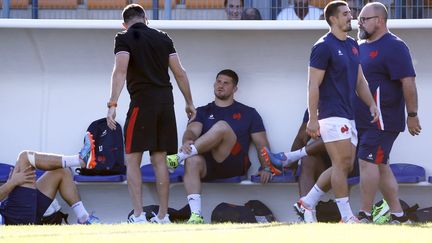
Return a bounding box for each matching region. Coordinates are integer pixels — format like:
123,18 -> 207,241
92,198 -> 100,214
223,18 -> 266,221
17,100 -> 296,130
318,117 -> 358,146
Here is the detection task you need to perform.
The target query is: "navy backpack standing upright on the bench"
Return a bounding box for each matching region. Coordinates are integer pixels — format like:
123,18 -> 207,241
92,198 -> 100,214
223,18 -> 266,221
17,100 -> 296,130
76,118 -> 126,175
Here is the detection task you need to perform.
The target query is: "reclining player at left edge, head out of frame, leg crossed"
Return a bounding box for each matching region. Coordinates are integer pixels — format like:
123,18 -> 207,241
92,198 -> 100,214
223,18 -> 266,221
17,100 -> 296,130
0,133 -> 100,225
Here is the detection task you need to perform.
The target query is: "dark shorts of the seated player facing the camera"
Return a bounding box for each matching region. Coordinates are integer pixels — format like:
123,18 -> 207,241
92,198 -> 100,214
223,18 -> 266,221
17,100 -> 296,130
202,142 -> 251,181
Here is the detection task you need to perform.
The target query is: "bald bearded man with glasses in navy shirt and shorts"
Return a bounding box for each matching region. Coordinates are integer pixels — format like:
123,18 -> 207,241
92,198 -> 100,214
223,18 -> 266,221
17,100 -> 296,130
356,2 -> 421,223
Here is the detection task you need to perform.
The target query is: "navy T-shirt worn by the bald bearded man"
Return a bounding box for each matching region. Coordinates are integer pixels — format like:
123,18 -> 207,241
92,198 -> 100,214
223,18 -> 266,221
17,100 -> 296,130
356,33 -> 416,132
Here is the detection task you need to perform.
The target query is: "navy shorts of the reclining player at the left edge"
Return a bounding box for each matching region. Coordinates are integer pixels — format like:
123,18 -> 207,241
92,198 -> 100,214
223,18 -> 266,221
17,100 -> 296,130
0,186 -> 53,225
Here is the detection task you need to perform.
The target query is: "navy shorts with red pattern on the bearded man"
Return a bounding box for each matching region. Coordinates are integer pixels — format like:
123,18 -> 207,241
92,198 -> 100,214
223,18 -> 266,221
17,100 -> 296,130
358,129 -> 399,165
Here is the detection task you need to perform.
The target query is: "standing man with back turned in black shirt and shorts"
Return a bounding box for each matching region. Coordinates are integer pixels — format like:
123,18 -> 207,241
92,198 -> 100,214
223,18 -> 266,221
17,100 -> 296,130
107,4 -> 196,223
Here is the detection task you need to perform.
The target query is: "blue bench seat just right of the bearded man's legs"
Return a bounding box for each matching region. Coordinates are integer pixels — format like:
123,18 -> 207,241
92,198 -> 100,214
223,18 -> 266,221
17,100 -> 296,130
390,163 -> 426,183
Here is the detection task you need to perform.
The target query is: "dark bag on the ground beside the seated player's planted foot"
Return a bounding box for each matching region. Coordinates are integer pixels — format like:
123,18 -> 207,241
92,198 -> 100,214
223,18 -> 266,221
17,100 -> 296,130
211,200 -> 276,223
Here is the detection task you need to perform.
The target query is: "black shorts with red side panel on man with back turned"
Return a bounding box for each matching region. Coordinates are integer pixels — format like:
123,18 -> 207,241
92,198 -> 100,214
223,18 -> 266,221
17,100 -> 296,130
124,101 -> 178,154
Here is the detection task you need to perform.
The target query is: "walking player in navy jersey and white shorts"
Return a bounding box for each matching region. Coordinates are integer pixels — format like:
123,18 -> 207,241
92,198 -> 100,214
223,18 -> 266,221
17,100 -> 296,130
294,1 -> 378,223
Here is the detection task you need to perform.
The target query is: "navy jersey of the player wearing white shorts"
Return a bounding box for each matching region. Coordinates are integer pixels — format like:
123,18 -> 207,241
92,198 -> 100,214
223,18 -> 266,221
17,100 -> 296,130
309,32 -> 360,120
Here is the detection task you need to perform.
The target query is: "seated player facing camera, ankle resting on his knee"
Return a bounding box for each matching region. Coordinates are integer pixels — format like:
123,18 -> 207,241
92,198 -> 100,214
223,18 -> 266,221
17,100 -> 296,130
168,69 -> 272,224
